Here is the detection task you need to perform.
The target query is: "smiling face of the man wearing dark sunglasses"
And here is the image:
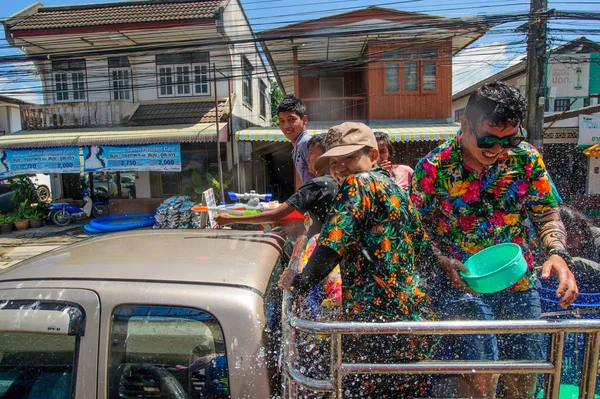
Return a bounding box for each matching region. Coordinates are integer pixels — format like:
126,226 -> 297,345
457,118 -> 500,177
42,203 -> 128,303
460,116 -> 519,172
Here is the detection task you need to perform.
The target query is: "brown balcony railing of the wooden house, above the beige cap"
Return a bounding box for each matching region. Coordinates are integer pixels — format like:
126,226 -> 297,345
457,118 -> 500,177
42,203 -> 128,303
302,97 -> 367,121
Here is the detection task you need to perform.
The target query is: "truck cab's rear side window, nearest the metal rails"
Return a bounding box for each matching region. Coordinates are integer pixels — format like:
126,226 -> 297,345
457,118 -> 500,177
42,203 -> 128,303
108,305 -> 229,399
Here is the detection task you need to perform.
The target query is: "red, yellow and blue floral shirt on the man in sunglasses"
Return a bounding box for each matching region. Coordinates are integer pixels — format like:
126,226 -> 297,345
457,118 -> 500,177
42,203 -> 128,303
411,132 -> 556,291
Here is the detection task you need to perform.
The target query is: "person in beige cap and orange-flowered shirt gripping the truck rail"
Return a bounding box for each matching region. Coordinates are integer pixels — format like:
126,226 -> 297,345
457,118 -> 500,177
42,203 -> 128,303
279,122 -> 436,398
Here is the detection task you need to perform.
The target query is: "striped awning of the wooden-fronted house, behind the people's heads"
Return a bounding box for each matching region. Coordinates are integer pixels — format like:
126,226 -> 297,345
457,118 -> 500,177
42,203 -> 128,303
235,119 -> 460,142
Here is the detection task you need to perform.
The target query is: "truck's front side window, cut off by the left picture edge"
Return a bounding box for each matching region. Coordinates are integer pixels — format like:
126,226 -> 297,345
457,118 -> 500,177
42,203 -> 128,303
0,301 -> 85,399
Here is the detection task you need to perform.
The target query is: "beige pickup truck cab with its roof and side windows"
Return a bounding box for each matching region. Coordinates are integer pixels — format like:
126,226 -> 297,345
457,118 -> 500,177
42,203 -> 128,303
0,230 -> 283,399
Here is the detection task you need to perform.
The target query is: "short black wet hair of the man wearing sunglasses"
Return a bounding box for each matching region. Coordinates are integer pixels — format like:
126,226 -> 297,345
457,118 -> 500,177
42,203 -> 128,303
465,82 -> 527,126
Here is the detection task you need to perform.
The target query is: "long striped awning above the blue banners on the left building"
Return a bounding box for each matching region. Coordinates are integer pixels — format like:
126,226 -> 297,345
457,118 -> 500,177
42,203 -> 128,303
0,123 -> 220,148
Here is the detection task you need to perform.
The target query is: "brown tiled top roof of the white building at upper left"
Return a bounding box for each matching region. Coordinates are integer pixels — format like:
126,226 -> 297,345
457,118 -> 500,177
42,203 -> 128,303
11,0 -> 220,30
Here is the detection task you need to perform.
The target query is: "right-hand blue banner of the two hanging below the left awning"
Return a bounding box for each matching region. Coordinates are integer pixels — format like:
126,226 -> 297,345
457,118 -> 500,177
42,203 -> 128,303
83,143 -> 181,172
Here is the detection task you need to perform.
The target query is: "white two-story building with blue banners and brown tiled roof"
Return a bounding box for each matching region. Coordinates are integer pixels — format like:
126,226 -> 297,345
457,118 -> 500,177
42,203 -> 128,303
0,0 -> 271,212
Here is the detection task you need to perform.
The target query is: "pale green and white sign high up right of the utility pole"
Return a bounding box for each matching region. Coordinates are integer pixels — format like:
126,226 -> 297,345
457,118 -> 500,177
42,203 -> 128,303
546,54 -> 590,98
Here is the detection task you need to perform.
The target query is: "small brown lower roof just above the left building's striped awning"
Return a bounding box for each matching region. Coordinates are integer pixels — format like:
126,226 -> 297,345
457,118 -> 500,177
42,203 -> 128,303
126,101 -> 227,126
